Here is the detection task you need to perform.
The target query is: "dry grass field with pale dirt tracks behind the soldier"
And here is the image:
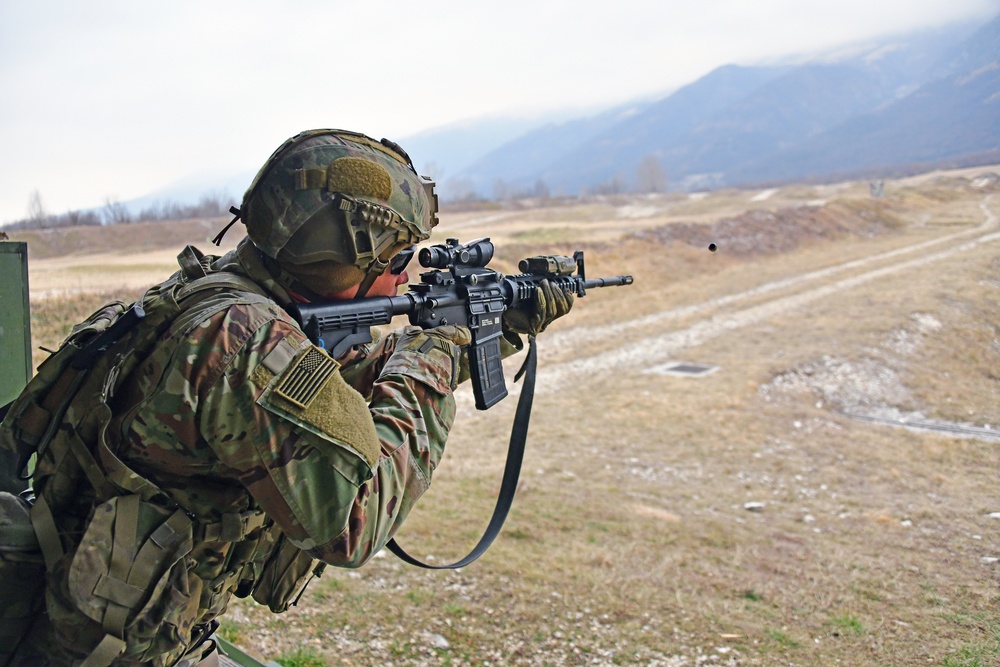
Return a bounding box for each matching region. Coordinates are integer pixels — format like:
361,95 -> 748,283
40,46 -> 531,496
12,168 -> 1000,667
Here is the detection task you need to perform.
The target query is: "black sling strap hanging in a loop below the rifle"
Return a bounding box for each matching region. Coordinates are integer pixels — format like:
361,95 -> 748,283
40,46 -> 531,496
386,336 -> 538,570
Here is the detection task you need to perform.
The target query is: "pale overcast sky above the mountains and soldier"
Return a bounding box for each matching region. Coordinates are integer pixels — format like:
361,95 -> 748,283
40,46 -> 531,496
0,0 -> 1000,222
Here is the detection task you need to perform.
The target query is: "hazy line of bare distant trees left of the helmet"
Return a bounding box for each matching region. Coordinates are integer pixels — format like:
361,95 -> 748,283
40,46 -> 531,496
4,190 -> 232,230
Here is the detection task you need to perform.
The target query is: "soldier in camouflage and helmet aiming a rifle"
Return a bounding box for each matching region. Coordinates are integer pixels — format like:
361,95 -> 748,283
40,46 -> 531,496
0,130 -> 572,667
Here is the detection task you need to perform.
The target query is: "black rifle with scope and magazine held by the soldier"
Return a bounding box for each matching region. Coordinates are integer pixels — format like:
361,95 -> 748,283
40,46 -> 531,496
289,238 -> 632,410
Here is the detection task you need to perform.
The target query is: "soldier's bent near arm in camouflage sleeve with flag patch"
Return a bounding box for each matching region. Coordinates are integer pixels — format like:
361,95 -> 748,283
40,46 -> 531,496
201,320 -> 455,567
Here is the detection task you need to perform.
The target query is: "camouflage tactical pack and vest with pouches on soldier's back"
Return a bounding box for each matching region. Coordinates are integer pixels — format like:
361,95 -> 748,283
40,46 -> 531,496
0,246 -> 319,667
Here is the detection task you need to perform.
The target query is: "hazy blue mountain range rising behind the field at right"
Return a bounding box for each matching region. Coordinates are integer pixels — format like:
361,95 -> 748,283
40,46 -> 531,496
442,17 -> 1000,199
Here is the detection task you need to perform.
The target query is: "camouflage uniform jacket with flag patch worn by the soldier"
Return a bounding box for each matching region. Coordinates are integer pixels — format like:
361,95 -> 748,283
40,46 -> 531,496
131,240 -> 458,567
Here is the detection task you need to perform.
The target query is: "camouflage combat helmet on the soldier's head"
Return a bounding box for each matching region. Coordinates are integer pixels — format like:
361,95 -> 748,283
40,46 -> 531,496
240,130 -> 437,275
